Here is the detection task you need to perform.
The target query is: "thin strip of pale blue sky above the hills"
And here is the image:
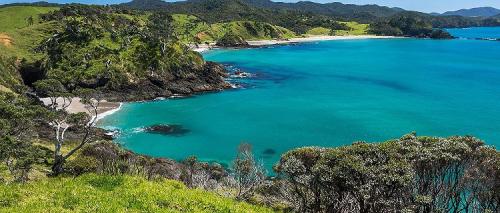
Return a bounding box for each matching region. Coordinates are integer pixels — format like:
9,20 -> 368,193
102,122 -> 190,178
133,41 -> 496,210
0,0 -> 500,13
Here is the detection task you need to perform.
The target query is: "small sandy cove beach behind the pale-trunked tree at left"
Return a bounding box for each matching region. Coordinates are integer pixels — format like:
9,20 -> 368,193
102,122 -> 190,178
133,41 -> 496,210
40,97 -> 122,120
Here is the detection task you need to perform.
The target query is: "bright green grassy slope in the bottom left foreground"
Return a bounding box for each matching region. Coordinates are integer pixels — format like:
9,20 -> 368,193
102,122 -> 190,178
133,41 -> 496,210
0,174 -> 272,213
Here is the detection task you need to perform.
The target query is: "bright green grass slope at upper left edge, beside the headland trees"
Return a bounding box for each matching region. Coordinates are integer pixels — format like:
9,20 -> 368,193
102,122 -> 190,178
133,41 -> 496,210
0,6 -> 57,59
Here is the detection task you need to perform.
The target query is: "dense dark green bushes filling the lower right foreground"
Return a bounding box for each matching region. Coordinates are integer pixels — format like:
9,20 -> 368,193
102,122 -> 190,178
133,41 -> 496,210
275,134 -> 500,212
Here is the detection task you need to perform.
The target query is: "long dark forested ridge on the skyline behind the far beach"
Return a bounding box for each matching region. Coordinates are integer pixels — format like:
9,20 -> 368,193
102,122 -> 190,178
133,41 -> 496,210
120,0 -> 404,22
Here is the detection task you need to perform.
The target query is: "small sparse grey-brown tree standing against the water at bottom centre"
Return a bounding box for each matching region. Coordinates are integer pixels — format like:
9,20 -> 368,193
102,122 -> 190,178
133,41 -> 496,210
232,143 -> 266,200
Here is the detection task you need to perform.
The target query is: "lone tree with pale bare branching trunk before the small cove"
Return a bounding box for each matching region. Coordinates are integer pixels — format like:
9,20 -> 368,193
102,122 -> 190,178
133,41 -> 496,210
34,79 -> 102,176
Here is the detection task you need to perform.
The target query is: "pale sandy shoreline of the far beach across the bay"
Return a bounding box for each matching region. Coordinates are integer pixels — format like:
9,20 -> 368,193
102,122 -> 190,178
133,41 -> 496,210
191,35 -> 403,53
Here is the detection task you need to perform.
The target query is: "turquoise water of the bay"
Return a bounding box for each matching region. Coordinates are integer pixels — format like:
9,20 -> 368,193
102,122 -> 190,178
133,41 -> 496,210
100,28 -> 500,168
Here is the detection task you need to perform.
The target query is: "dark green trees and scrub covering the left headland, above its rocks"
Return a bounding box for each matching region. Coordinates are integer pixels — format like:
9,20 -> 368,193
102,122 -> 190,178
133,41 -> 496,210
33,5 -> 203,94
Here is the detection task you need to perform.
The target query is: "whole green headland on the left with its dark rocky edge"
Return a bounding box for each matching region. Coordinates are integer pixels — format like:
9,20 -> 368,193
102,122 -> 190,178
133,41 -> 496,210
0,5 -> 228,100
